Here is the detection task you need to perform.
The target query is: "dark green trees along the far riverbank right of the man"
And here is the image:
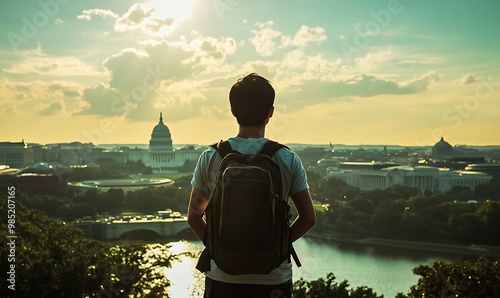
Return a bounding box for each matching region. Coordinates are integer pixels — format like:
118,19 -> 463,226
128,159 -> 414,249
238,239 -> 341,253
309,175 -> 500,245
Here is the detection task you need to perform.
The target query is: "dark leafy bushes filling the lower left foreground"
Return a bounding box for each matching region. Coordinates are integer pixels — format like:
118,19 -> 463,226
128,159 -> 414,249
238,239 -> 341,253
0,202 -> 181,297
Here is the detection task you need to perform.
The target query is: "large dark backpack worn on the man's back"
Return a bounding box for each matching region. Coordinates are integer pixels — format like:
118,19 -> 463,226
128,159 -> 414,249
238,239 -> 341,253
205,141 -> 300,275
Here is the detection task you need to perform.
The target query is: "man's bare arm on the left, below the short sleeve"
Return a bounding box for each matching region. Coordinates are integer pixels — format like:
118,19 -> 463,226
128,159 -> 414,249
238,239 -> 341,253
188,187 -> 208,241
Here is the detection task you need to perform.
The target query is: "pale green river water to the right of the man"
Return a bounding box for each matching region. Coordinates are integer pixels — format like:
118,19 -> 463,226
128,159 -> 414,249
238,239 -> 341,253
294,238 -> 442,297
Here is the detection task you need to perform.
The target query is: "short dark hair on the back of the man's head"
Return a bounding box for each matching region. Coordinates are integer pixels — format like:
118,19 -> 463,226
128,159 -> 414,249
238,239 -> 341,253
229,73 -> 274,126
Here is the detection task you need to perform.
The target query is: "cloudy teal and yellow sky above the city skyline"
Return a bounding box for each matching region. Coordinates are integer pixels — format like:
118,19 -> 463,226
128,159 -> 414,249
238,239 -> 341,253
0,0 -> 500,146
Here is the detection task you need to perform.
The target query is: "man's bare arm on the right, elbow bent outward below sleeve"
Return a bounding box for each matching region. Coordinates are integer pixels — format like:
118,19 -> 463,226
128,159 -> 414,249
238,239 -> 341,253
290,189 -> 316,242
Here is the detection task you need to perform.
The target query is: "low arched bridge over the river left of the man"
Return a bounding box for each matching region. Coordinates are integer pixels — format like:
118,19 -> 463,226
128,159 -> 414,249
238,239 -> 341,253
71,217 -> 193,240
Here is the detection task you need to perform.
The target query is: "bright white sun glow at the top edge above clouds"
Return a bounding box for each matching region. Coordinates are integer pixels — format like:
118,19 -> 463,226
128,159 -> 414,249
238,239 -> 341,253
149,0 -> 196,24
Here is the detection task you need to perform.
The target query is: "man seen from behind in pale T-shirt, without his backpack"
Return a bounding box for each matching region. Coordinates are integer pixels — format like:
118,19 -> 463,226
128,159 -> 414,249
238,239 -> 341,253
188,73 -> 316,298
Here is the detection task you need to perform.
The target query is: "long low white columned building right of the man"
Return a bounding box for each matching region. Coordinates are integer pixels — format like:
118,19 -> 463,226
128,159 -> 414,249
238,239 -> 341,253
328,166 -> 492,194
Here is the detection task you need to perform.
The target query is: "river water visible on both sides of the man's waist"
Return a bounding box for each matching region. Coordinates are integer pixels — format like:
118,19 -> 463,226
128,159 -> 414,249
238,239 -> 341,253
159,238 -> 450,298
